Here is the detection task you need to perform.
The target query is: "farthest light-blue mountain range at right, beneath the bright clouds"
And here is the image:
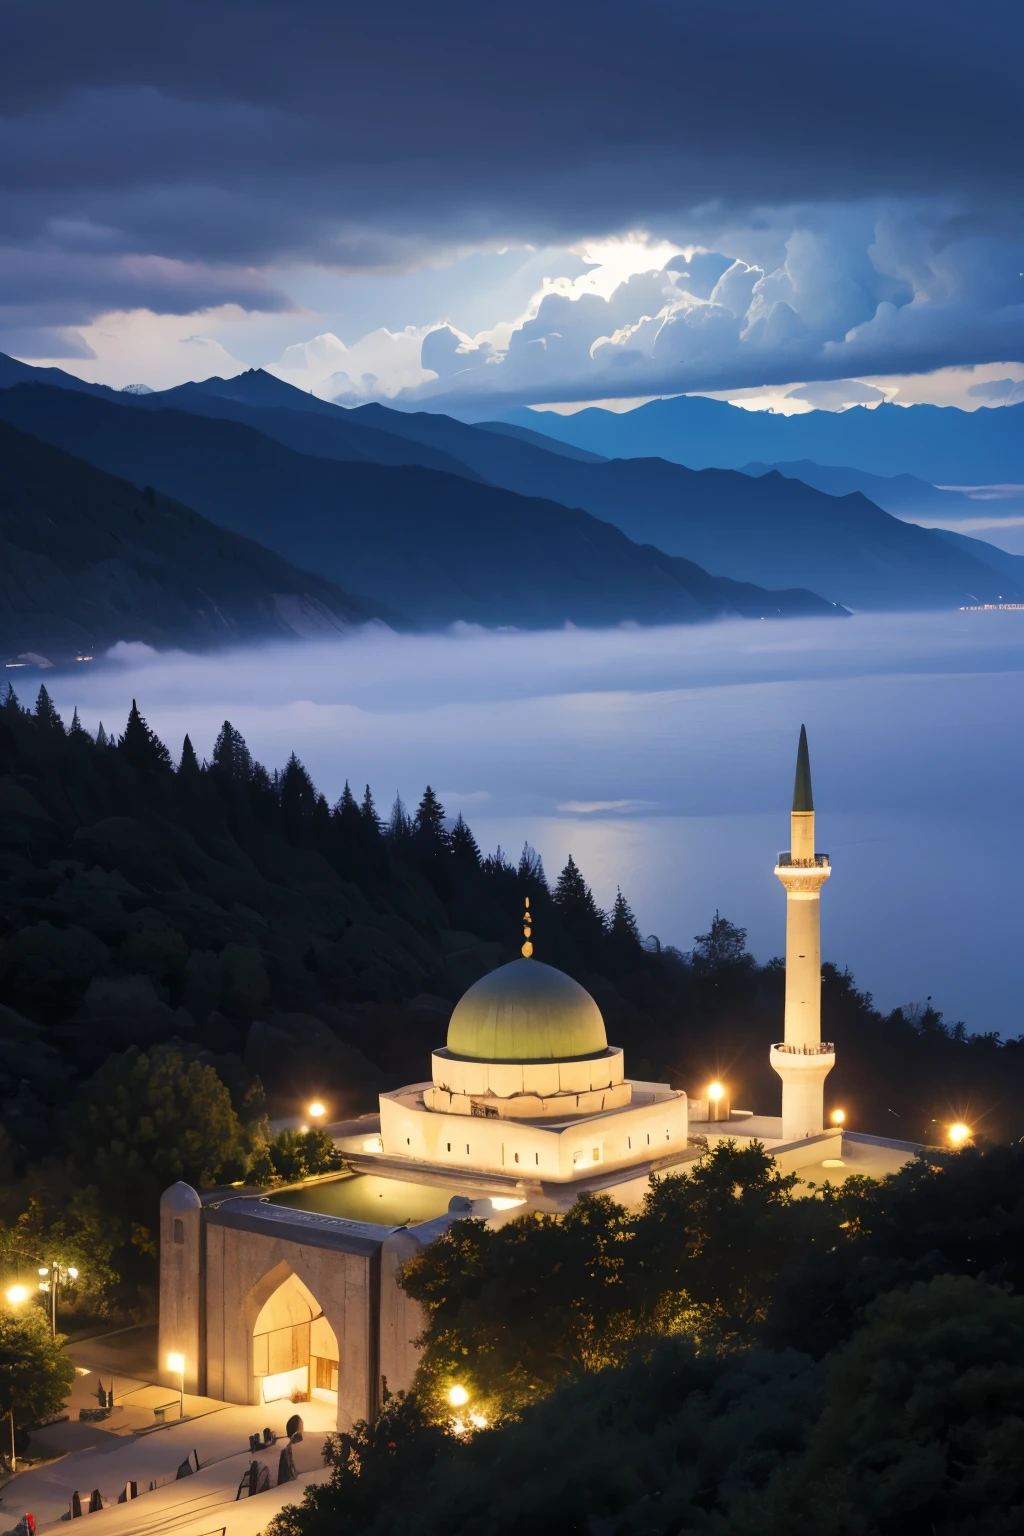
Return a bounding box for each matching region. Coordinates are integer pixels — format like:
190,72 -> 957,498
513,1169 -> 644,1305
505,395 -> 1024,485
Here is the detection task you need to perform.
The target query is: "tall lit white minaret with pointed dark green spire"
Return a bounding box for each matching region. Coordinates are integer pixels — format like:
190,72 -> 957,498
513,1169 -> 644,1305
771,725 -> 835,1141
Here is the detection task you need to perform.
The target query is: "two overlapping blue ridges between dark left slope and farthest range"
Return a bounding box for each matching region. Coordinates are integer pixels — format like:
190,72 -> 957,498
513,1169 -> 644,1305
0,358 -> 1024,642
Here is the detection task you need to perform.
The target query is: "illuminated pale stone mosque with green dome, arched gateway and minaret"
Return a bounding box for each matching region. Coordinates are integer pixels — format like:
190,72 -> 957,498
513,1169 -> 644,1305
160,728 -> 917,1428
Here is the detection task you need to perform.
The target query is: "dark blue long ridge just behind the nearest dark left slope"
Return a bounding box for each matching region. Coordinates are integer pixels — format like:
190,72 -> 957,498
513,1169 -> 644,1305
0,386 -> 837,628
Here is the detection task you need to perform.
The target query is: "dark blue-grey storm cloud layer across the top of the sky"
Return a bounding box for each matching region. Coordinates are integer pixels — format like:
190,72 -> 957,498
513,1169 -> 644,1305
0,0 -> 1024,266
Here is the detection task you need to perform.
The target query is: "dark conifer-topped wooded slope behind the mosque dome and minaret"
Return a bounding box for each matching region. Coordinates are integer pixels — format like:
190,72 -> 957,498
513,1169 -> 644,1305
0,688 -> 1024,1304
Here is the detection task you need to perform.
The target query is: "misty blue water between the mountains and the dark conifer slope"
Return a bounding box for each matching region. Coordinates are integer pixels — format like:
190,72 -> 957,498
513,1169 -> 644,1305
47,613 -> 1024,1035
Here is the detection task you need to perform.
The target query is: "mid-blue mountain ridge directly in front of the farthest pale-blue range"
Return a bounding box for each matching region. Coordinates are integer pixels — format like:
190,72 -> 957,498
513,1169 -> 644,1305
4,369 -> 1007,622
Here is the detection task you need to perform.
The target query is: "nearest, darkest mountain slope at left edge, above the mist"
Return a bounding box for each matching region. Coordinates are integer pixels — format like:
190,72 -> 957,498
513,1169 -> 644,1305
0,421 -> 373,660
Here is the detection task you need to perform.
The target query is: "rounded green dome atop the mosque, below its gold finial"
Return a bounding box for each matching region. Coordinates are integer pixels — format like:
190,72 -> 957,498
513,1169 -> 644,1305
448,960 -> 608,1061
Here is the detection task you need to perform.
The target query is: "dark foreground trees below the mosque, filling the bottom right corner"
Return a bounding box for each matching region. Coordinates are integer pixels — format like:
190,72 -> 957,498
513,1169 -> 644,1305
269,1146 -> 1024,1536
